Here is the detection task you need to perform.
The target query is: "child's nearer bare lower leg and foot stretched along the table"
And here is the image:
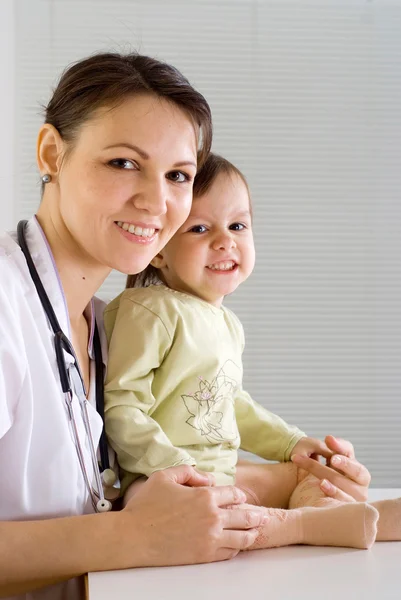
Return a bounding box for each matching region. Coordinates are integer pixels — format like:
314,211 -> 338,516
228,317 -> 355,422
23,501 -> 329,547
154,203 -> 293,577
238,502 -> 379,550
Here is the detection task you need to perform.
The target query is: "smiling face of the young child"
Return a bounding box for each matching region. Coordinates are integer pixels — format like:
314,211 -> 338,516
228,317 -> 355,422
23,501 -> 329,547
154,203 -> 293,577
155,174 -> 255,307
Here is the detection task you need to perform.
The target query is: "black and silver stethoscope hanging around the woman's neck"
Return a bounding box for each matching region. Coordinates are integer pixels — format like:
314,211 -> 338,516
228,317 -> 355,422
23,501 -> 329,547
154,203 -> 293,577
17,221 -> 118,512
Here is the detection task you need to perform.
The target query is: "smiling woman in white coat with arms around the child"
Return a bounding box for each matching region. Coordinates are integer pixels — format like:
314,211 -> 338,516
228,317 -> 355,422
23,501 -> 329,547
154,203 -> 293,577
0,54 -> 369,599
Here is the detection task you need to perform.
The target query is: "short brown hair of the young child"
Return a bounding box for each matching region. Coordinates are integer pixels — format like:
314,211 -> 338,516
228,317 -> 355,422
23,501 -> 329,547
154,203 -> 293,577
126,152 -> 248,288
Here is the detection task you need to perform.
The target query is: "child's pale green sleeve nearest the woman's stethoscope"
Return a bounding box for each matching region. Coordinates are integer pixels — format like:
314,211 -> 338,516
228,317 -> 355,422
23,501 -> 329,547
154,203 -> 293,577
105,298 -> 195,477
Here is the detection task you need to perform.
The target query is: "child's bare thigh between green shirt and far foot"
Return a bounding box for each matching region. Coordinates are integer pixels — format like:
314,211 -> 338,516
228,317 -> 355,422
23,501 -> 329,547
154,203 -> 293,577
235,460 -> 298,508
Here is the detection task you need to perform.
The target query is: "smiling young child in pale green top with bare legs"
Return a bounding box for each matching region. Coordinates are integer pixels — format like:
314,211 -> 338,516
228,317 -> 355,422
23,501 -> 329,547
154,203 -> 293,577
105,154 -> 401,548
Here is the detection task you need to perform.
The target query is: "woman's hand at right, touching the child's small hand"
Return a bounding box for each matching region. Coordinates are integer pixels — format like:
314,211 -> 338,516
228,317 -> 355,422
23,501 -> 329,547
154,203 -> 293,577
291,435 -> 371,502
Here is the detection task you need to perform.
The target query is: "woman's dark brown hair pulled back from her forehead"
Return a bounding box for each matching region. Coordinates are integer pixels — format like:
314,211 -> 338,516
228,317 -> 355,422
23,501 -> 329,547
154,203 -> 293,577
45,53 -> 212,166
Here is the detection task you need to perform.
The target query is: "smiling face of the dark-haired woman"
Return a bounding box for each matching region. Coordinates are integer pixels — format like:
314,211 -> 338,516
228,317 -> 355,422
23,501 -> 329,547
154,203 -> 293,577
57,95 -> 197,273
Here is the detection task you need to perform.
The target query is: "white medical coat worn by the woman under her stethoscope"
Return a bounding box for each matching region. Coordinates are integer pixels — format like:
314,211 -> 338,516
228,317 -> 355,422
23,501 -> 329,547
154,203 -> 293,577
0,218 -> 107,600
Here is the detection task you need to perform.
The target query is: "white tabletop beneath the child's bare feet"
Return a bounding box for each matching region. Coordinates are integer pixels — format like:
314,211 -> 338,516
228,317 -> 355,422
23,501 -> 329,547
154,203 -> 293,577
89,489 -> 401,600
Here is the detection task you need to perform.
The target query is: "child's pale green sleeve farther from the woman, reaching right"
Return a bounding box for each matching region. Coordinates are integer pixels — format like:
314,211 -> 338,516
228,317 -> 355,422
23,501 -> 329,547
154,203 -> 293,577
235,389 -> 306,462
